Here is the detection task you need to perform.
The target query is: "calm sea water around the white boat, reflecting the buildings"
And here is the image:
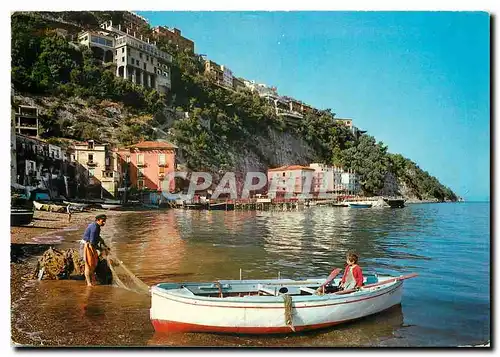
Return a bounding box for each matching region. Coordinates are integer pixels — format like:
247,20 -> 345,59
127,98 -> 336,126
14,203 -> 490,346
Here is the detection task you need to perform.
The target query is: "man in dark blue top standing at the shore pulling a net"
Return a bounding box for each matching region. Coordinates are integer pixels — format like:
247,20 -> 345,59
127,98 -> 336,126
80,214 -> 110,286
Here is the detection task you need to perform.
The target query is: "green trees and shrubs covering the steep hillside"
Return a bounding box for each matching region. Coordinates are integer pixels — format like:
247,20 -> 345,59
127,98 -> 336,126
12,12 -> 457,200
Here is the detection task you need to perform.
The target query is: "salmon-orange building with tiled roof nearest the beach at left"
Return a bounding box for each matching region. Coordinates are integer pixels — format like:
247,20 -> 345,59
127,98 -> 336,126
116,141 -> 177,192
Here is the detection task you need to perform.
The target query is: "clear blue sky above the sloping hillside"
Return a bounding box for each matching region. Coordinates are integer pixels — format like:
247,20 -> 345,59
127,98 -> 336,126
138,11 -> 490,200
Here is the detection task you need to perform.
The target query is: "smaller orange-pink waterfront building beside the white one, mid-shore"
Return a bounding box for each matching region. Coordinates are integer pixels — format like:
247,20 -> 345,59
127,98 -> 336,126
267,165 -> 314,196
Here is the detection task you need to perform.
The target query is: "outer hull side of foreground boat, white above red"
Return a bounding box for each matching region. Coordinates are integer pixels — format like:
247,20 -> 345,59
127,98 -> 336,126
150,282 -> 403,334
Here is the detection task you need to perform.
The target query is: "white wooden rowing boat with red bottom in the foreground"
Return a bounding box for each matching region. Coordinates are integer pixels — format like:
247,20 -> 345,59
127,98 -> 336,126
150,274 -> 416,334
